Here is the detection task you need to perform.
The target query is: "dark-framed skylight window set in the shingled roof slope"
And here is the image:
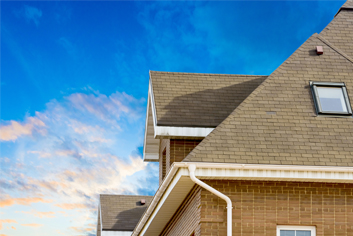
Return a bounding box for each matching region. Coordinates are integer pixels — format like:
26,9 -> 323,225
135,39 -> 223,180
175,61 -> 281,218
310,81 -> 352,115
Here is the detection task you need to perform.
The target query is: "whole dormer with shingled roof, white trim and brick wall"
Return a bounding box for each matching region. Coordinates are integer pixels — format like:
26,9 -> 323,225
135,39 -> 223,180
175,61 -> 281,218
143,71 -> 267,181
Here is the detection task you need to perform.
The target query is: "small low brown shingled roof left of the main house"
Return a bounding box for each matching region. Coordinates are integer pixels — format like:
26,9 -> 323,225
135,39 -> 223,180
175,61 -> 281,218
98,194 -> 153,231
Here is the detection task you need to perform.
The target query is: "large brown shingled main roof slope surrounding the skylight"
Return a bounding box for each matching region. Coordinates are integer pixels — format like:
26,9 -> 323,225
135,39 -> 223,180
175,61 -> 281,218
184,11 -> 353,166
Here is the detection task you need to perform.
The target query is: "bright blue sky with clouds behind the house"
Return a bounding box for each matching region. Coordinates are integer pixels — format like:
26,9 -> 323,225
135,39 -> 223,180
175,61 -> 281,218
0,1 -> 344,235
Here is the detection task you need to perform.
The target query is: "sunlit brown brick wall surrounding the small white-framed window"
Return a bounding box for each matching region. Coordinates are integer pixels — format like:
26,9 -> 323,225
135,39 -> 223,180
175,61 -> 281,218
201,180 -> 353,236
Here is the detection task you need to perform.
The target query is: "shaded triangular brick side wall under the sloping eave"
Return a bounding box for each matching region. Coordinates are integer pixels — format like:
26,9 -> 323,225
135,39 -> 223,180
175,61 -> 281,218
160,186 -> 201,236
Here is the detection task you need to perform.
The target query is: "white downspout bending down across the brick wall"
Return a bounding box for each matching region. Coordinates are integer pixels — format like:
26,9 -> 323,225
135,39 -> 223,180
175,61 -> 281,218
188,164 -> 233,236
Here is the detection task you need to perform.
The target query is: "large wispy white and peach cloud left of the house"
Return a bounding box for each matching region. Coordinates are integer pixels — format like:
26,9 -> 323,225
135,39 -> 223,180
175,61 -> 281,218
0,89 -> 158,235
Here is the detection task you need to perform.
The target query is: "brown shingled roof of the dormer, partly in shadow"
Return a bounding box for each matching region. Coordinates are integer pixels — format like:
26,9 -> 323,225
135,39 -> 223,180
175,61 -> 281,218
150,71 -> 267,127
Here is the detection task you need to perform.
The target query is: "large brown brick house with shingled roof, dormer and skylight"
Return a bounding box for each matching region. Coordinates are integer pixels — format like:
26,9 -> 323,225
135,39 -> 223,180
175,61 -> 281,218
98,0 -> 353,236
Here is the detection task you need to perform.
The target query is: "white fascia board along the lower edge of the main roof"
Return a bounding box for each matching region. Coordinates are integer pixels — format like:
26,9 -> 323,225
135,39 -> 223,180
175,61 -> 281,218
133,162 -> 353,236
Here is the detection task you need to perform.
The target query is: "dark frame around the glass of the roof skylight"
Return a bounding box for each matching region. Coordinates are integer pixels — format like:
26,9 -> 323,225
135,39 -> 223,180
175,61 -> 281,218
310,81 -> 352,116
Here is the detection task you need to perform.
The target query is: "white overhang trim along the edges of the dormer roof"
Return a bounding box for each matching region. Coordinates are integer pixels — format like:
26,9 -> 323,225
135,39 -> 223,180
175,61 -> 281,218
143,75 -> 214,161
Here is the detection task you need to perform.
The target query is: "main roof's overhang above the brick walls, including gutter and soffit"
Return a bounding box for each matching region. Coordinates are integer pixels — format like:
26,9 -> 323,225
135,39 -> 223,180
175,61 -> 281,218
132,162 -> 353,236
